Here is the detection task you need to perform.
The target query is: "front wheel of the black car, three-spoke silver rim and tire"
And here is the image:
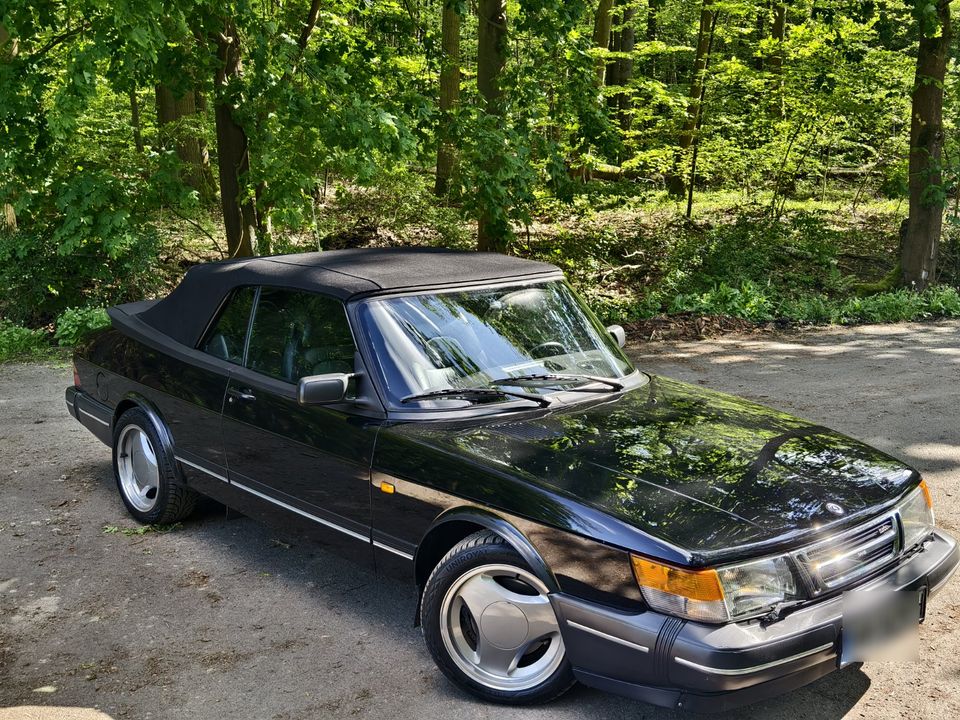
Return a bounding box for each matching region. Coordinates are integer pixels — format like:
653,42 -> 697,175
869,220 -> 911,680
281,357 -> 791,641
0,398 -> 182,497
421,531 -> 574,705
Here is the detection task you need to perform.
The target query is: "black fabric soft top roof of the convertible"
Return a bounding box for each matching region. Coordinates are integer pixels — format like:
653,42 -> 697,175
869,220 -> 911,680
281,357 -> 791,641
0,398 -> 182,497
118,248 -> 560,347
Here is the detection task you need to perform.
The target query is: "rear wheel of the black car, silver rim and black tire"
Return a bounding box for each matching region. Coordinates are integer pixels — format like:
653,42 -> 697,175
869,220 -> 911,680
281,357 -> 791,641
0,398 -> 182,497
113,408 -> 197,525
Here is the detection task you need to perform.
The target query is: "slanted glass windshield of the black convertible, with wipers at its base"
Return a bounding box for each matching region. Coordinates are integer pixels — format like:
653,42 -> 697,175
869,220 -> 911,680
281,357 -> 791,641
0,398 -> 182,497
359,281 -> 633,408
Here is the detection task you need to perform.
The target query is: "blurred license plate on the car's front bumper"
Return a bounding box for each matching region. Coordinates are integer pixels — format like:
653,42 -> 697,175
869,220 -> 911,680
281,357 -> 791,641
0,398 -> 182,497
840,588 -> 926,667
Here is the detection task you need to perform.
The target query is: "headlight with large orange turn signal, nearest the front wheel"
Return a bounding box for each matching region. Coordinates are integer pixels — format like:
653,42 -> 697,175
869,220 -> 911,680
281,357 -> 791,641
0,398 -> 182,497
631,555 -> 797,623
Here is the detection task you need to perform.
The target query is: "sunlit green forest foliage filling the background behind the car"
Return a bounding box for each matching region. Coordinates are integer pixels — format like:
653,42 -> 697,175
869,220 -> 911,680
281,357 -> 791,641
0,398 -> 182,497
0,0 -> 960,344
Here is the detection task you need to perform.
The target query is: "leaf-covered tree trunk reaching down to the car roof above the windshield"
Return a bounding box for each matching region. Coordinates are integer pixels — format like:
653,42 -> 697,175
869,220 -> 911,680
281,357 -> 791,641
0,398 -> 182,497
477,0 -> 510,252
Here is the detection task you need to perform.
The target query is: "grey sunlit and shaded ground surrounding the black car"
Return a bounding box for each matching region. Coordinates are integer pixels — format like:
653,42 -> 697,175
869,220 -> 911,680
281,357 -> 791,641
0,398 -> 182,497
0,322 -> 960,720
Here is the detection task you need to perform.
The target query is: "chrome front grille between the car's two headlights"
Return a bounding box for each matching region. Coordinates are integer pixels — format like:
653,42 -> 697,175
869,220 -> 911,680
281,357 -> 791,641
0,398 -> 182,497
797,513 -> 901,591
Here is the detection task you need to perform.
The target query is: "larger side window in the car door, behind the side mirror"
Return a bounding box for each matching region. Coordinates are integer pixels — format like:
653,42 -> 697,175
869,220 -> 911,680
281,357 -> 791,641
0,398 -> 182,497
247,287 -> 355,382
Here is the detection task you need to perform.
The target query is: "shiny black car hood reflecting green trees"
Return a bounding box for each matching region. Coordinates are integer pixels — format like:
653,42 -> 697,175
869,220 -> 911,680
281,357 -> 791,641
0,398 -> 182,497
402,376 -> 917,556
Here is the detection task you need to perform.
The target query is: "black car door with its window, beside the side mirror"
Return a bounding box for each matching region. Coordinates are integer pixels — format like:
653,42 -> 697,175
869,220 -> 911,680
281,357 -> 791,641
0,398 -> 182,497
223,287 -> 376,561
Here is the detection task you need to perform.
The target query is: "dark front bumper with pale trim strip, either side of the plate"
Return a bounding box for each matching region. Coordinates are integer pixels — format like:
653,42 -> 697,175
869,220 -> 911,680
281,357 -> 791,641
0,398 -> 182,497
551,530 -> 960,712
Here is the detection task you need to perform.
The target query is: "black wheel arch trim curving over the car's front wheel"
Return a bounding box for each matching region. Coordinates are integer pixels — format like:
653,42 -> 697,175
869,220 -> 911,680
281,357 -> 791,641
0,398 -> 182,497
413,507 -> 559,592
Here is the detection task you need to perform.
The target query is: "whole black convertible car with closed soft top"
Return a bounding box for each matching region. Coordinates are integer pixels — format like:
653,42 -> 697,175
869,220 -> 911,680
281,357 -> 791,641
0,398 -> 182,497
66,249 -> 960,711
